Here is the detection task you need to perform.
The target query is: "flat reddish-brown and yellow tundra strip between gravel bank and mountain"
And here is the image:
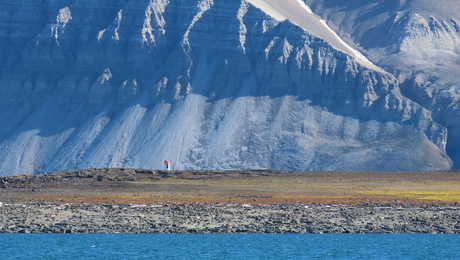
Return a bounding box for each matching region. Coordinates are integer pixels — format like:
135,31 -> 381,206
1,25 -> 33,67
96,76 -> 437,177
0,169 -> 460,205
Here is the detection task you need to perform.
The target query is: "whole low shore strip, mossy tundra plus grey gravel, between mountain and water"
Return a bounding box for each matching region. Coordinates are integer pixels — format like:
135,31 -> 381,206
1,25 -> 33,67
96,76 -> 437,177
0,169 -> 460,233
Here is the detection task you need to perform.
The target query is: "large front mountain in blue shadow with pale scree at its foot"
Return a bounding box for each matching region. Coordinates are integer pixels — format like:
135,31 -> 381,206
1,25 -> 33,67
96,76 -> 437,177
0,0 -> 452,175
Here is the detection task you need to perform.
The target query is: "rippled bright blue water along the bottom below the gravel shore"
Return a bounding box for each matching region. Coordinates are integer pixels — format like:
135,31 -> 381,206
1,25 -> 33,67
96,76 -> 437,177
0,234 -> 460,259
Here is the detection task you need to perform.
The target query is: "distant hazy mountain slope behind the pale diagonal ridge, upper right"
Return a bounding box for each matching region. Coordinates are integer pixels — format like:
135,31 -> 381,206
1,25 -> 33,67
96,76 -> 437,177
307,0 -> 460,168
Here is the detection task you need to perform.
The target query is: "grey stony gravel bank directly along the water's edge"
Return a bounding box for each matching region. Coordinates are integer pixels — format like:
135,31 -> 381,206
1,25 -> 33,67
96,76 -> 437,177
0,203 -> 460,233
